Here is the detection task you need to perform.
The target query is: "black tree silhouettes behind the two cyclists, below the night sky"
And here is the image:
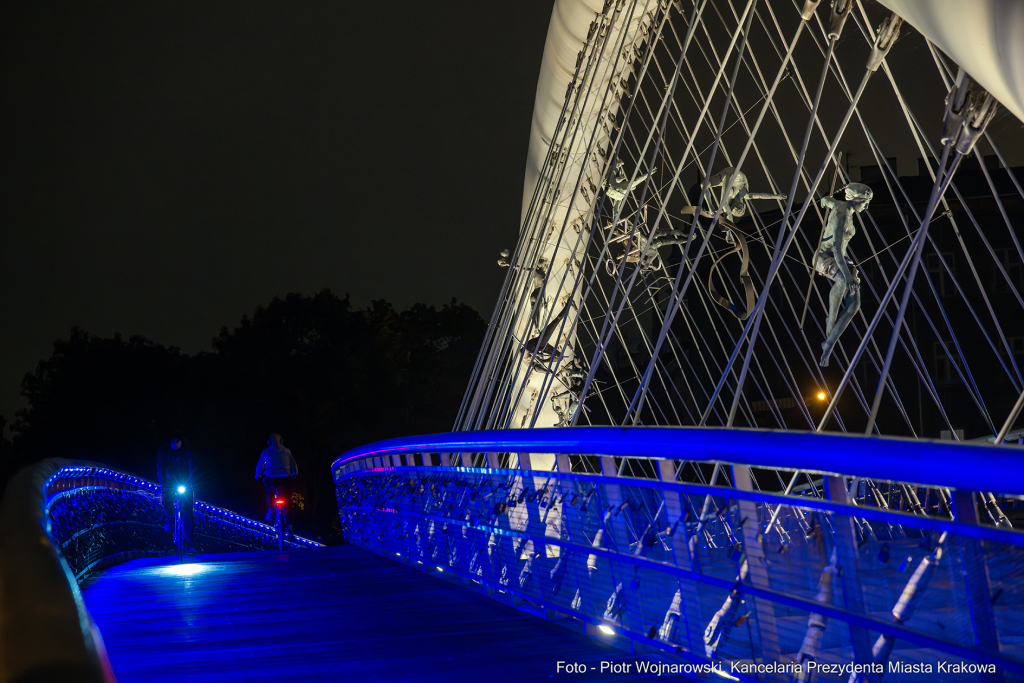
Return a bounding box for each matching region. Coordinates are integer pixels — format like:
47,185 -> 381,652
0,291 -> 485,539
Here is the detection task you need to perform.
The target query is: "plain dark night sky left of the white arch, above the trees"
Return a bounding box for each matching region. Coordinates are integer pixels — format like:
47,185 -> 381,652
0,0 -> 553,420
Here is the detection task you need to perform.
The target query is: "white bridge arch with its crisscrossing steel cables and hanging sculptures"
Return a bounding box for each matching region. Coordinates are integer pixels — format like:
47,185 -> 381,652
457,0 -> 1024,454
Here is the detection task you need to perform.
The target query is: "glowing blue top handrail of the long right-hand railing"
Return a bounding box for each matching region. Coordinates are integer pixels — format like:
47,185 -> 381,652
332,427 -> 1024,496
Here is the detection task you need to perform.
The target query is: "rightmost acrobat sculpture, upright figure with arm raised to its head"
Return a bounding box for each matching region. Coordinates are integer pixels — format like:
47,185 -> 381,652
814,182 -> 872,368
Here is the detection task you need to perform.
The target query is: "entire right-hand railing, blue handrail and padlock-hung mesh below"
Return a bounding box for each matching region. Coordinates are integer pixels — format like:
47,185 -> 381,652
333,427 -> 1024,681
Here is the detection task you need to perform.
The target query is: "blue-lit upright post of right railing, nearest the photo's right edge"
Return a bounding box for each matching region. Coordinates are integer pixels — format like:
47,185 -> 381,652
952,489 -> 1002,681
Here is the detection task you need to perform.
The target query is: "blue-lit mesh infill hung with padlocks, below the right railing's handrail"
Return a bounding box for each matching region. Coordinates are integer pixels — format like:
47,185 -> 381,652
337,467 -> 1024,681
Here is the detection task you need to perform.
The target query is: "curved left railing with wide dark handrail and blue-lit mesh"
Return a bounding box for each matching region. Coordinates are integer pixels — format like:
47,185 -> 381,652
0,459 -> 319,683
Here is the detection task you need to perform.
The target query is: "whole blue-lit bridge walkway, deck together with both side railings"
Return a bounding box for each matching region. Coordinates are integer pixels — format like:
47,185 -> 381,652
6,427 -> 1024,683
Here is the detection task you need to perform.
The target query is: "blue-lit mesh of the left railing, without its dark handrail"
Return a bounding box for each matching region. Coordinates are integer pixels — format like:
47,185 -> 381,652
43,465 -> 322,581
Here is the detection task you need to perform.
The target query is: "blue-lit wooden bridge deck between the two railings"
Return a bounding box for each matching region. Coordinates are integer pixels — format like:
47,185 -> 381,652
77,546 -> 663,683
